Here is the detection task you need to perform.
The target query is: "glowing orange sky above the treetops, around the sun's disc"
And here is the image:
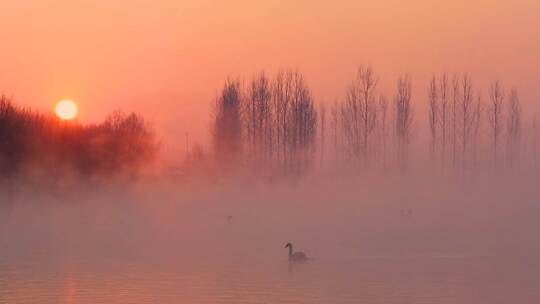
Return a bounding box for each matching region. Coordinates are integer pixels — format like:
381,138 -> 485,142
0,0 -> 540,149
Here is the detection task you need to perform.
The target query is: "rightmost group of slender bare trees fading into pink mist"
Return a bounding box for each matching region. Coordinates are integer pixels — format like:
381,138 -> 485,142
428,74 -> 538,175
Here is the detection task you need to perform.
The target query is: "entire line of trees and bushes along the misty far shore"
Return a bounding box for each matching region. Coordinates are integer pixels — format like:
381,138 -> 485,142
0,66 -> 539,177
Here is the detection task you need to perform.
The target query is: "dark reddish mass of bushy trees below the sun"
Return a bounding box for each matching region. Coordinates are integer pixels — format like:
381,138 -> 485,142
0,95 -> 158,178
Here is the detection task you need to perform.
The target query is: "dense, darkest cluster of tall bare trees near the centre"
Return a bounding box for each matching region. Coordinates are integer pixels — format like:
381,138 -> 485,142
212,69 -> 317,174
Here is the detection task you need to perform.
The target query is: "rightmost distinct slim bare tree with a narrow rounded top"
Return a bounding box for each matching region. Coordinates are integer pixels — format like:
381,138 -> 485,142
506,89 -> 521,164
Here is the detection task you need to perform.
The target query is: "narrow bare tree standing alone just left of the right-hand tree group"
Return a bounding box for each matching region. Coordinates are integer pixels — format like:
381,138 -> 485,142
394,75 -> 414,168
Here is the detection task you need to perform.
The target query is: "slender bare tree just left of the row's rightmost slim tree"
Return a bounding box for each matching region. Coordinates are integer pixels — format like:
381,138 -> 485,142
488,80 -> 504,168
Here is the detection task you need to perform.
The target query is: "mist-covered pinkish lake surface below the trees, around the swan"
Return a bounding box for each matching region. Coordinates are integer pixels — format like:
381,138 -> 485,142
0,171 -> 540,303
